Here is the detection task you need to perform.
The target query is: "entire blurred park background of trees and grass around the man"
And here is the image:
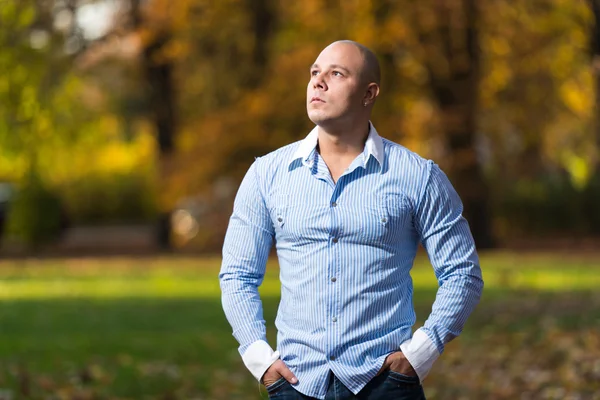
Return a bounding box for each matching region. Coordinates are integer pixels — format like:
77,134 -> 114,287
0,0 -> 600,399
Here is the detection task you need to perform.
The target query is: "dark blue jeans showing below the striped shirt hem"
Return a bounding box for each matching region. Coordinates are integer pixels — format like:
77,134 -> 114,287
267,370 -> 425,400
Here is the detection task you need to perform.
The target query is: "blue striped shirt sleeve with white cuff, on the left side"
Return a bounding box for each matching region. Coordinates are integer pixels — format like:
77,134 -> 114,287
219,162 -> 277,380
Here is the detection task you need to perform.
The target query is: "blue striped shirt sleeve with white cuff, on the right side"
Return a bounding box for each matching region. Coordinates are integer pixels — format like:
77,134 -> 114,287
400,161 -> 483,381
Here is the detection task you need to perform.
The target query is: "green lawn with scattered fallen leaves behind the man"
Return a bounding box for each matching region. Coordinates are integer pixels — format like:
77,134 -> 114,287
0,253 -> 600,400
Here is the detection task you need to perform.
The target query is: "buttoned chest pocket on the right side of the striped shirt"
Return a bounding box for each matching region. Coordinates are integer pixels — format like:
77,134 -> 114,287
359,195 -> 411,245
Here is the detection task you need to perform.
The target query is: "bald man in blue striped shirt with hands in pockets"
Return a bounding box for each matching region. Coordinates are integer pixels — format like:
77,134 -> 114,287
219,41 -> 483,399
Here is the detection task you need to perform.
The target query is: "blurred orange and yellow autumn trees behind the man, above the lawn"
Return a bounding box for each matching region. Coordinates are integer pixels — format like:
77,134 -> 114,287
0,0 -> 600,249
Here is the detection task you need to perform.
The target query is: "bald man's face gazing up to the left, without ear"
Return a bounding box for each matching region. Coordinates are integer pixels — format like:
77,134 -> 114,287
306,43 -> 365,125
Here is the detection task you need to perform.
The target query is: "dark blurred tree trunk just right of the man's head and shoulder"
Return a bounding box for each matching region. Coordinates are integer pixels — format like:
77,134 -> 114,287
419,0 -> 494,249
